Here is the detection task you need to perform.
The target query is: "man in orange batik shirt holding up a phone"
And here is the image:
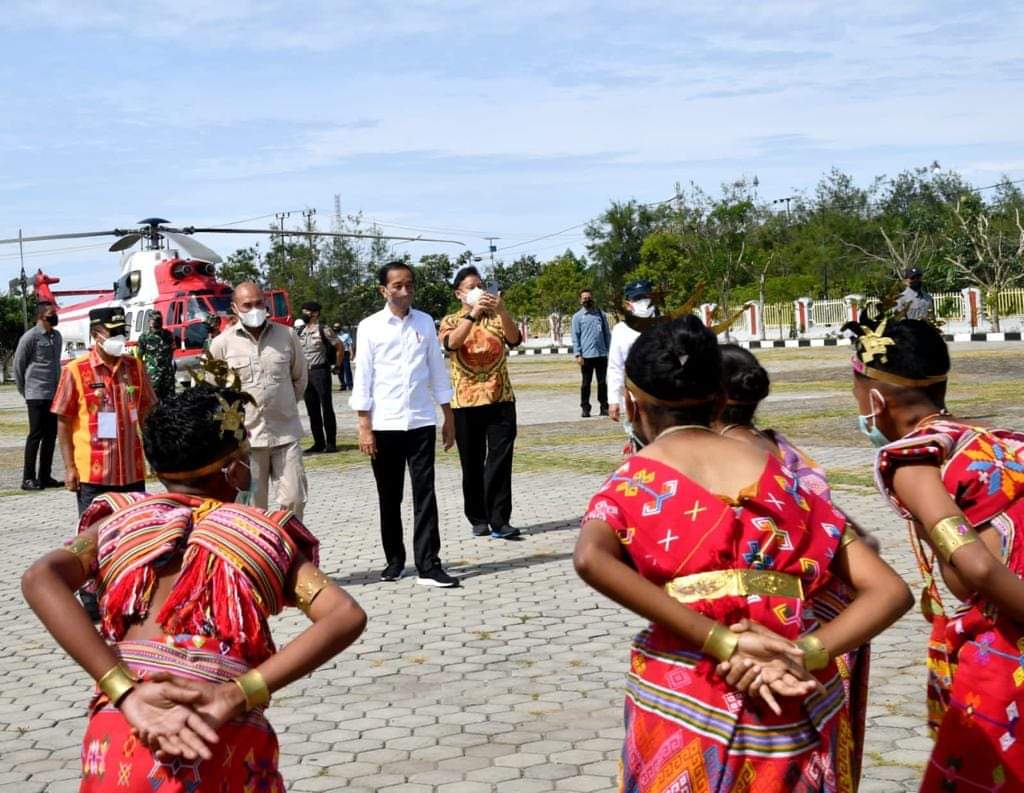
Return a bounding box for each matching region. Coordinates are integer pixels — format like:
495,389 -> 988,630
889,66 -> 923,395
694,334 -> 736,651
438,265 -> 521,540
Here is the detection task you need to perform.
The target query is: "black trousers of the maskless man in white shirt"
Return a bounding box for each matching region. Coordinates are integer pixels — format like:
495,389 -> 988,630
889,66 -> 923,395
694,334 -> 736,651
373,426 -> 441,573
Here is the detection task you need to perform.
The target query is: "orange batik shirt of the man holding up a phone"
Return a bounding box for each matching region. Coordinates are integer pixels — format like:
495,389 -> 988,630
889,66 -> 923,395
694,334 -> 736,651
437,310 -> 515,408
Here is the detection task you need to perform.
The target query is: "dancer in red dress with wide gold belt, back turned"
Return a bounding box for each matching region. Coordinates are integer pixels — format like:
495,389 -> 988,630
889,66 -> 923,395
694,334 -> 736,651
575,317 -> 912,793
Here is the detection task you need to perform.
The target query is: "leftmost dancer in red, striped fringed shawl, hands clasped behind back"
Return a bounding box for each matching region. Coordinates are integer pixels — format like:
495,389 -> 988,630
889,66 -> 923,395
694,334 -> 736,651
22,385 -> 366,793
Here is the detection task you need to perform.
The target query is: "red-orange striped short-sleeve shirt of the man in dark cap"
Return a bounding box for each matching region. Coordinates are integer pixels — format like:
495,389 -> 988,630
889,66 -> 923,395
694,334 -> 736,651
50,349 -> 156,485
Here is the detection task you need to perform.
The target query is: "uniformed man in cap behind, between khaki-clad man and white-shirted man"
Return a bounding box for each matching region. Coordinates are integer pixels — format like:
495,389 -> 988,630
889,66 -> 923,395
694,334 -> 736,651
299,300 -> 345,454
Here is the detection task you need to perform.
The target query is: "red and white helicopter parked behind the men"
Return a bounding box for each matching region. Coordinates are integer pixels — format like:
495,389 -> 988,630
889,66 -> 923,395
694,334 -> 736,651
0,217 -> 465,371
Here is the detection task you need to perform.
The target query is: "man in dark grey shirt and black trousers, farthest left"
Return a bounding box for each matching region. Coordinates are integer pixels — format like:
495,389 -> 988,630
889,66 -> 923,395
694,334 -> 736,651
14,302 -> 63,490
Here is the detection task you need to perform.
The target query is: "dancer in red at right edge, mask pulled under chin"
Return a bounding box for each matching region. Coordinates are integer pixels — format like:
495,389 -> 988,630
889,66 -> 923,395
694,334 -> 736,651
847,317 -> 1024,793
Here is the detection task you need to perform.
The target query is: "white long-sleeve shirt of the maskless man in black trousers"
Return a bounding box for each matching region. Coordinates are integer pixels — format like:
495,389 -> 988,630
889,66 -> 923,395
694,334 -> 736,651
348,306 -> 452,430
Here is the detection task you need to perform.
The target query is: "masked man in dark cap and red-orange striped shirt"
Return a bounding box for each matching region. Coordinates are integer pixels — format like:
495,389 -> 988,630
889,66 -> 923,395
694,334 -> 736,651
50,307 -> 157,514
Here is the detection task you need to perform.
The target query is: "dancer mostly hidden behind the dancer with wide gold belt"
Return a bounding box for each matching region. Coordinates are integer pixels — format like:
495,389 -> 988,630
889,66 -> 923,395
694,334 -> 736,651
712,344 -> 879,779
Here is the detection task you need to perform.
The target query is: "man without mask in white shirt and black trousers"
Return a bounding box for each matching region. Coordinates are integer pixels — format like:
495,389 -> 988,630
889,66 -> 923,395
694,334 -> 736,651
348,261 -> 459,587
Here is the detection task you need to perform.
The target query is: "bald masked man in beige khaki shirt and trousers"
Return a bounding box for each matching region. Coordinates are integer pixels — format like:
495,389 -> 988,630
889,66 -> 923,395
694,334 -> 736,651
210,281 -> 306,520
